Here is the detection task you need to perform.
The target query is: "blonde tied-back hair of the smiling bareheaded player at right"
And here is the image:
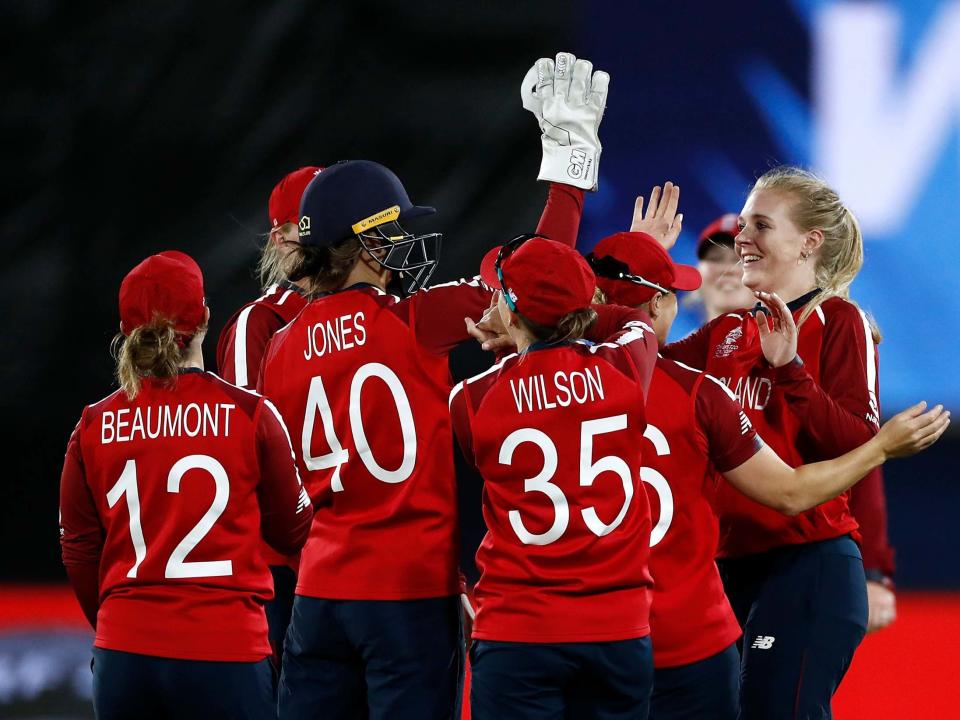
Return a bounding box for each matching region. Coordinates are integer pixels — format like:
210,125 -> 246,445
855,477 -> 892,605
751,165 -> 880,342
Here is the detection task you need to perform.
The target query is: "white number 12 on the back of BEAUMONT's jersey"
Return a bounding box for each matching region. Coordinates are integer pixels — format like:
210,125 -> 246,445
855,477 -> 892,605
107,455 -> 233,578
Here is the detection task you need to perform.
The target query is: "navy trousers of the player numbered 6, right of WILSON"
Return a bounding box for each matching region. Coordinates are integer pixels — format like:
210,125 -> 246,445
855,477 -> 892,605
650,643 -> 740,720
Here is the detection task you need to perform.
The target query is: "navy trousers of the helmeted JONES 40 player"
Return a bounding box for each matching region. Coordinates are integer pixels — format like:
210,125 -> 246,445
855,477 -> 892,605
279,595 -> 464,720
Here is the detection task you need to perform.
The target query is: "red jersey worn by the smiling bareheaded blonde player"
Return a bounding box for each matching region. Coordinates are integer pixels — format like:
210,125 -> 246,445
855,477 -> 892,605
664,293 -> 880,557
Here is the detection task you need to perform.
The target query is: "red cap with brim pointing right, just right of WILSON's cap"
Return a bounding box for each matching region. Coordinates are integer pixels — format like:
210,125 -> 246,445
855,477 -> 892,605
593,232 -> 702,306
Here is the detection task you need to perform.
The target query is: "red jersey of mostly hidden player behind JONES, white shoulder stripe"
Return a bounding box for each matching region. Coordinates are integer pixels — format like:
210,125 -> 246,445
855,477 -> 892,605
217,283 -> 307,571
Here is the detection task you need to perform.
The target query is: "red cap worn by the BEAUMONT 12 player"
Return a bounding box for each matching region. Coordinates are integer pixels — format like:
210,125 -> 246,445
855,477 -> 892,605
120,250 -> 206,336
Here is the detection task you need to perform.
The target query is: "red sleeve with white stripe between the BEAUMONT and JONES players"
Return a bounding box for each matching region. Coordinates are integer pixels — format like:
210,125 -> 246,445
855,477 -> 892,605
217,304 -> 283,390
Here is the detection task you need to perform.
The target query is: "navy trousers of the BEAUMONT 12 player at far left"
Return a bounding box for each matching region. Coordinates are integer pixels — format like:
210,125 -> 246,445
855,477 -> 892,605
93,648 -> 276,720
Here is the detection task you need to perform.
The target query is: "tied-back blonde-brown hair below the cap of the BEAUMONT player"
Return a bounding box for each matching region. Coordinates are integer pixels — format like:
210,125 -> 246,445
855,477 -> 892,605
112,319 -> 183,400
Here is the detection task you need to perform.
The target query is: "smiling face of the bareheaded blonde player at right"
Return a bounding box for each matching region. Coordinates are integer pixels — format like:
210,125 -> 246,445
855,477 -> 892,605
736,190 -> 822,300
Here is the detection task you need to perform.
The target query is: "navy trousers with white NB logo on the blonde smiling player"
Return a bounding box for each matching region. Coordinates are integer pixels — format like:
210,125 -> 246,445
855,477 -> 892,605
718,535 -> 867,720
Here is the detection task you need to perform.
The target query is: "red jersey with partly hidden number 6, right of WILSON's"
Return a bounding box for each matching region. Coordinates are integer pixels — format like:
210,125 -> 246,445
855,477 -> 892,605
640,358 -> 762,668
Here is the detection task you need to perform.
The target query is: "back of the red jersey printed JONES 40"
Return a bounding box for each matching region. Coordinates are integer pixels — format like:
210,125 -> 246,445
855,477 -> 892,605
262,284 -> 470,600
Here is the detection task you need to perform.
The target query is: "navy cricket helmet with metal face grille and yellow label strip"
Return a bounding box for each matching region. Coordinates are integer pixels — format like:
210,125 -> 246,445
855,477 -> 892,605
299,160 -> 442,293
